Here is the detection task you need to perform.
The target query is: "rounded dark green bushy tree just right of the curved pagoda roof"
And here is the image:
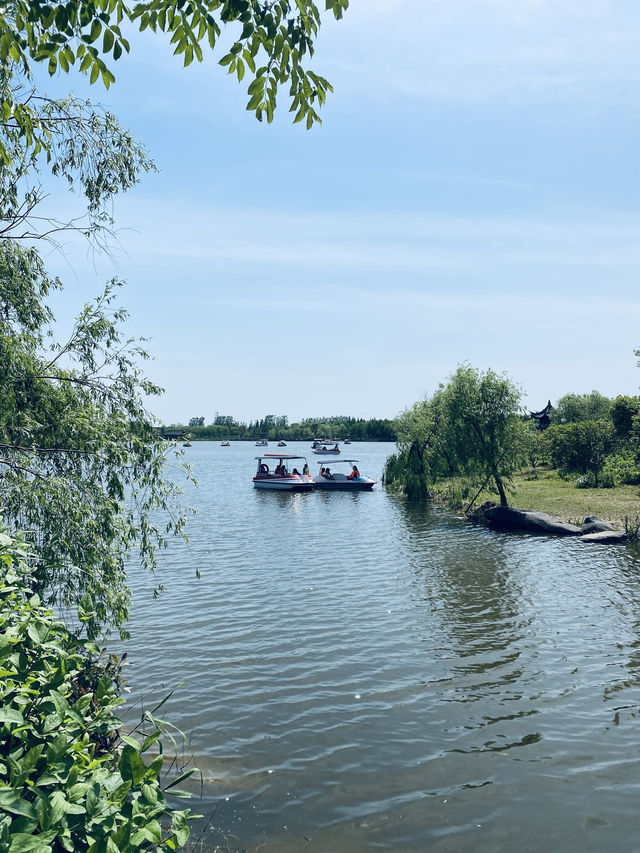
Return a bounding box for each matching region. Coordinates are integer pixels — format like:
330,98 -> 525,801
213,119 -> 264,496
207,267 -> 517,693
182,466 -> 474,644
546,420 -> 615,488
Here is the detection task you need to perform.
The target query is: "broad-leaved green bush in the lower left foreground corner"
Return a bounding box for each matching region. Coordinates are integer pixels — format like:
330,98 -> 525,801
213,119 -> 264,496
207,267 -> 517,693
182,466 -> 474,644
0,529 -> 189,853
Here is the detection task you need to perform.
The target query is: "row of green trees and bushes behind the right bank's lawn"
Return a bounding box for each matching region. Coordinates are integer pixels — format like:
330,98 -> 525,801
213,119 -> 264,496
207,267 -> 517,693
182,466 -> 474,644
384,353 -> 640,505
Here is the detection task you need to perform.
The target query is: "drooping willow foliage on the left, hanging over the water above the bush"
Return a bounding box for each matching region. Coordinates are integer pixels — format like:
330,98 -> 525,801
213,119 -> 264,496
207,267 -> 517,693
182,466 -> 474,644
0,241 -> 190,636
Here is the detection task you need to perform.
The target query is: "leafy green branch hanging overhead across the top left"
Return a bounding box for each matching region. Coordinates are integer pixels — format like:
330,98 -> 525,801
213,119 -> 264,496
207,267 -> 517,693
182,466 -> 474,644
0,0 -> 349,132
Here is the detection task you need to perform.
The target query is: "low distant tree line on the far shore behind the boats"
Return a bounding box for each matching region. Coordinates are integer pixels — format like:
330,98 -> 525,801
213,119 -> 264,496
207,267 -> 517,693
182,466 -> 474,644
170,413 -> 396,441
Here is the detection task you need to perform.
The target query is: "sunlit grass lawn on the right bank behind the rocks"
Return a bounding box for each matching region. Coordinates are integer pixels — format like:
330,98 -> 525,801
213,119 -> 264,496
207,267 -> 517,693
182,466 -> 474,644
475,469 -> 640,527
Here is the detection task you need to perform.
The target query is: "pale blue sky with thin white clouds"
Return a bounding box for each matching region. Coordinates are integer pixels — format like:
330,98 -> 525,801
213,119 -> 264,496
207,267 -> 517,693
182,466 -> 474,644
40,0 -> 640,422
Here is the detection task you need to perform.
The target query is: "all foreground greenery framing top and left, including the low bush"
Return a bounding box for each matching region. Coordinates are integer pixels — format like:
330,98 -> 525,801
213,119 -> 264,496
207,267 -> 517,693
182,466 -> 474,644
0,0 -> 348,853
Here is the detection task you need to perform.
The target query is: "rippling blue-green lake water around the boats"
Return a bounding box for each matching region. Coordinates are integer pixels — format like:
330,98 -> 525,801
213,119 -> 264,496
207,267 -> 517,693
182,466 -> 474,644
122,442 -> 640,853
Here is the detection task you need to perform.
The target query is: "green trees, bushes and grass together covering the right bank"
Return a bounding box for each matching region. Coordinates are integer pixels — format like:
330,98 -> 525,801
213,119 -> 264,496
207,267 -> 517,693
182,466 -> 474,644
385,365 -> 640,522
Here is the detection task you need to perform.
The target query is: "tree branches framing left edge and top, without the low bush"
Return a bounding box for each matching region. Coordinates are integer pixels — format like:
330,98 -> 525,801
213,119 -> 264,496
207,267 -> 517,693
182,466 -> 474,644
0,0 -> 348,634
